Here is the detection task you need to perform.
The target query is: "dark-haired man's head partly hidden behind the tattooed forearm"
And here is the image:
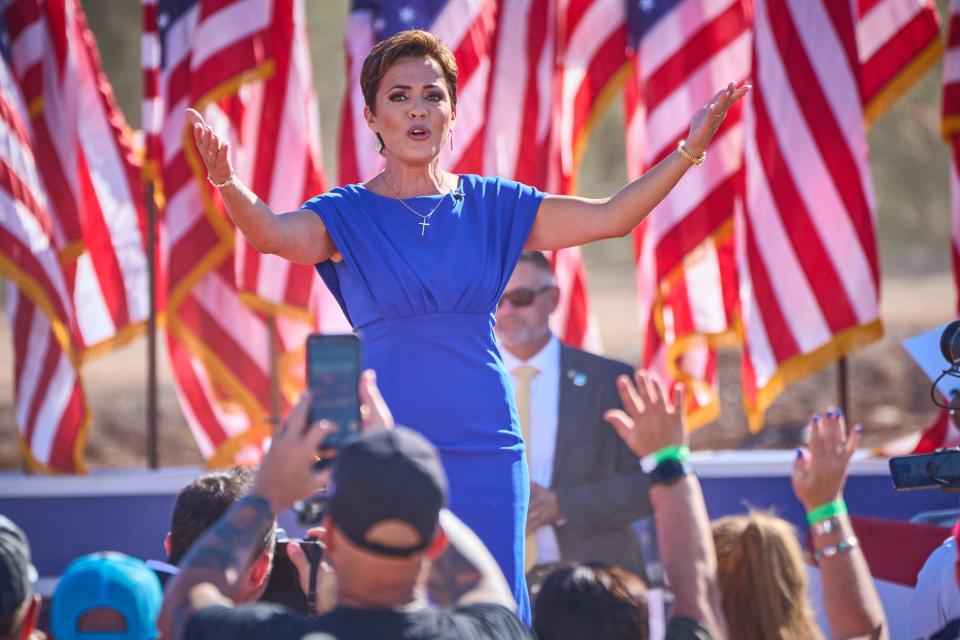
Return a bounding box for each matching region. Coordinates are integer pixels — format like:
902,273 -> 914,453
164,467 -> 276,602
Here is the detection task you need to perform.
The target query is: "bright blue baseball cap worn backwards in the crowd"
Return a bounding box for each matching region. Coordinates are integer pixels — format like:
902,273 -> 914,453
50,552 -> 163,640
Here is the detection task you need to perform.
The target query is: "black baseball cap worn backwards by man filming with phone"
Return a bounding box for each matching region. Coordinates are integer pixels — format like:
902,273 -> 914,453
327,427 -> 447,557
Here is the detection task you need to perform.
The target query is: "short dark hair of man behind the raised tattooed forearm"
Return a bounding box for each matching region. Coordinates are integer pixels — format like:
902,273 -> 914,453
169,467 -> 275,564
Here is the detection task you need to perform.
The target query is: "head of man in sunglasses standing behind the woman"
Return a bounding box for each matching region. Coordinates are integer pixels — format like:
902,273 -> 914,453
495,251 -> 560,359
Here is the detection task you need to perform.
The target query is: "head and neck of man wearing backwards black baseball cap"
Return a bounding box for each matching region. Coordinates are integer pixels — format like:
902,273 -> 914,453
324,427 -> 447,607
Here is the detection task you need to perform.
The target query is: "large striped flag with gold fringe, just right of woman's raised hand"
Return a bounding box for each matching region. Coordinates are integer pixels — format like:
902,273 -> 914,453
736,0 -> 882,427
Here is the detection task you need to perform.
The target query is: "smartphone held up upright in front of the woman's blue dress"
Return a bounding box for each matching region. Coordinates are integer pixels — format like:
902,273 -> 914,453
307,333 -> 360,450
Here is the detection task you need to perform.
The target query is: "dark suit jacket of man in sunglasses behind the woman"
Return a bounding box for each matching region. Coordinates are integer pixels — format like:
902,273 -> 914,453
550,345 -> 652,576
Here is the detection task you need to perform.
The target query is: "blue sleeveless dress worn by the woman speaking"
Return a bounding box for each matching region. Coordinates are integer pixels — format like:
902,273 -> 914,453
304,175 -> 545,623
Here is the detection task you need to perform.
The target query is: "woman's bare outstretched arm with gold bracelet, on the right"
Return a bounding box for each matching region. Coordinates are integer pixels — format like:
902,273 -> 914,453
526,83 -> 750,251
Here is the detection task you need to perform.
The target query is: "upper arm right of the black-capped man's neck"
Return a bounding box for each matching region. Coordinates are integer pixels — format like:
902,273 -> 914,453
427,509 -> 517,611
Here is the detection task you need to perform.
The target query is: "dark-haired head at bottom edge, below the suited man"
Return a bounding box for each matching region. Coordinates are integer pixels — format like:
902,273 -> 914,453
533,563 -> 648,640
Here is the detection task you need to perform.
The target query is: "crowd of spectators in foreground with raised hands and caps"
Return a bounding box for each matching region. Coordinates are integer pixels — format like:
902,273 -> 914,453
0,358 -> 960,640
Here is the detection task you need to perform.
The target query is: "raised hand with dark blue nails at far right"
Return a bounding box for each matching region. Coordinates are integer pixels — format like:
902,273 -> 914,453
793,411 -> 860,511
